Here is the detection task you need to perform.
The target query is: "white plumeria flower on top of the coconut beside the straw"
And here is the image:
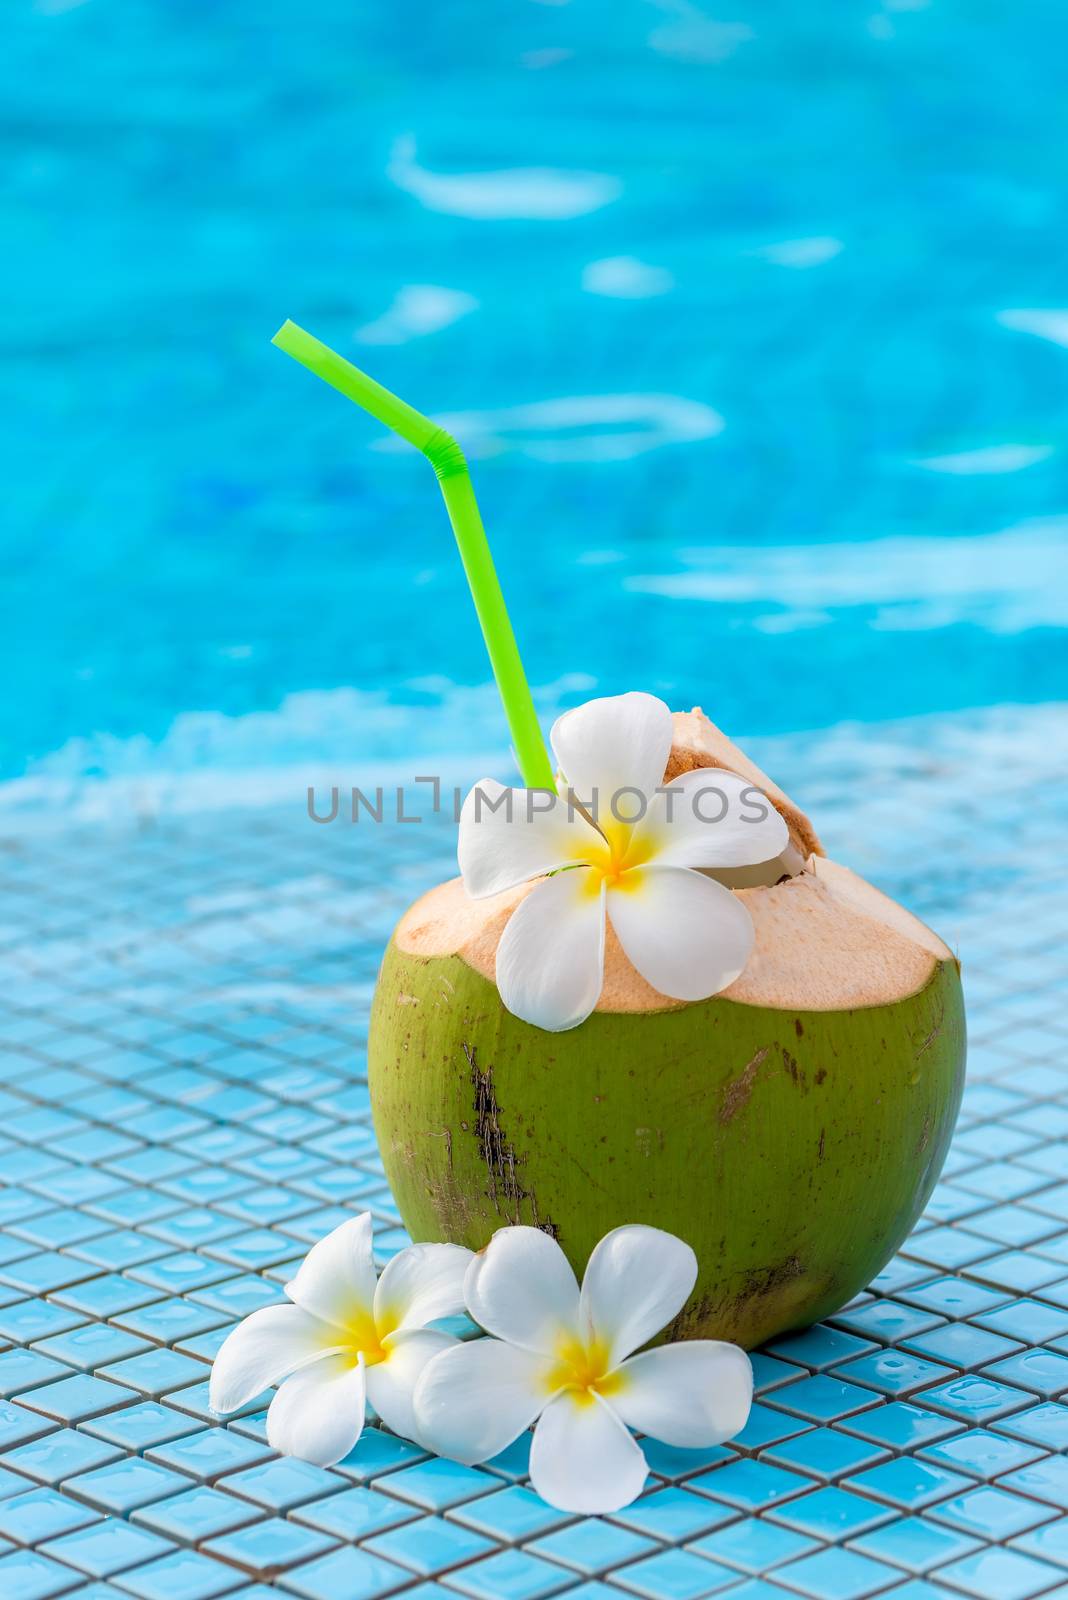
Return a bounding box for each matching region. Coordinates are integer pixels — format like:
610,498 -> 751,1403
459,693 -> 788,1032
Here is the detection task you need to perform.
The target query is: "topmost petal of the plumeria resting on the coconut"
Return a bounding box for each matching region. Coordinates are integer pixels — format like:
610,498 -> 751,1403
550,693 -> 673,827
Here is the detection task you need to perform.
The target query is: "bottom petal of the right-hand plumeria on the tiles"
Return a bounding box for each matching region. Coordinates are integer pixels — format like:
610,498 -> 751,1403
531,1389 -> 649,1517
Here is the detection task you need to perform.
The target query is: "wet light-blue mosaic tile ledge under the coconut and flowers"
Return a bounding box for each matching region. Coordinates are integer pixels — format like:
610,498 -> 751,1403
0,716 -> 1068,1600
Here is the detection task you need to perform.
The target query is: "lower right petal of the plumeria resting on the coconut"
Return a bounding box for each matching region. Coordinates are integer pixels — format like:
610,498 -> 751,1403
604,866 -> 755,1000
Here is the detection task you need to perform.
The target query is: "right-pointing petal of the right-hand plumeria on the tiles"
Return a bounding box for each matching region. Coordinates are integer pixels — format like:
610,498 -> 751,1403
611,1339 -> 753,1450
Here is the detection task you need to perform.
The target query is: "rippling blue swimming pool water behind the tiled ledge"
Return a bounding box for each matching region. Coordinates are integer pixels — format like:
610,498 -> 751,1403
0,0 -> 1068,778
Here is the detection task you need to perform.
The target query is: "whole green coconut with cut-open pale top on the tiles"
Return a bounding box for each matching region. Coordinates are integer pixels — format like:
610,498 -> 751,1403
369,710 -> 964,1347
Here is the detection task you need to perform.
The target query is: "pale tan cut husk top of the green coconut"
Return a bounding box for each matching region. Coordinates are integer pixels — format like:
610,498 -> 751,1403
393,709 -> 953,1011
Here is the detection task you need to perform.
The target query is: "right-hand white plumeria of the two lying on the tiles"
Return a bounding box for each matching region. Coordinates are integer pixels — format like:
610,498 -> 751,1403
414,1226 -> 753,1514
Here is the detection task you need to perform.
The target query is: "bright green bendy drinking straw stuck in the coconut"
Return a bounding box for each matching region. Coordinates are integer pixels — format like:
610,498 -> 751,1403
270,322 -> 555,789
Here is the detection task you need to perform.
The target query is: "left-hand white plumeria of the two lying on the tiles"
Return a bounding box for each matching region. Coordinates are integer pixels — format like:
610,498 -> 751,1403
209,1211 -> 472,1467
